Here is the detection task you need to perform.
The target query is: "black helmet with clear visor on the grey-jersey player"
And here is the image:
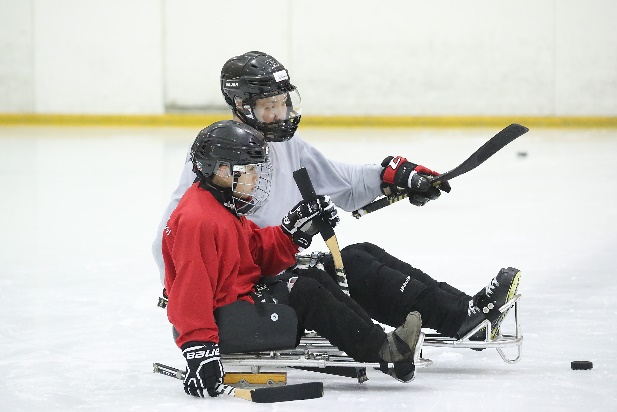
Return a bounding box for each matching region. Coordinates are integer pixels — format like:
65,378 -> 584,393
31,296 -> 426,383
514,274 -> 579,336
221,51 -> 302,142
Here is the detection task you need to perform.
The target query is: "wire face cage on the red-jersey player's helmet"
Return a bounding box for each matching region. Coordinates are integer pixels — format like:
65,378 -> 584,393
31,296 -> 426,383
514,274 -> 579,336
231,160 -> 272,215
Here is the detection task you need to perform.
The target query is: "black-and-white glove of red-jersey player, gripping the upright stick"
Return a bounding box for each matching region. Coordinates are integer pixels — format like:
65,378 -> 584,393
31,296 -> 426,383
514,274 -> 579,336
281,196 -> 339,249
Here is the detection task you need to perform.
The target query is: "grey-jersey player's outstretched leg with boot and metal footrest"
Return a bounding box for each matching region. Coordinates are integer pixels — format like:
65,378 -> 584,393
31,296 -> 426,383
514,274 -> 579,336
312,243 -> 523,363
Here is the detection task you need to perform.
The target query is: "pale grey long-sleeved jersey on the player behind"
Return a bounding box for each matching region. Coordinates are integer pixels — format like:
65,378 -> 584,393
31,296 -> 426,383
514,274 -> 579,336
152,134 -> 382,282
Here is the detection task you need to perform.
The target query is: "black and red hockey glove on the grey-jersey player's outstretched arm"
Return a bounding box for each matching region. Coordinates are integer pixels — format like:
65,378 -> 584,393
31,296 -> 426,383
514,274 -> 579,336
381,156 -> 451,206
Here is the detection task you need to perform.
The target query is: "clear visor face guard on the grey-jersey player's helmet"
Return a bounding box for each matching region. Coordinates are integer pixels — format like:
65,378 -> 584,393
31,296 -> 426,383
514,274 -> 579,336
235,87 -> 302,142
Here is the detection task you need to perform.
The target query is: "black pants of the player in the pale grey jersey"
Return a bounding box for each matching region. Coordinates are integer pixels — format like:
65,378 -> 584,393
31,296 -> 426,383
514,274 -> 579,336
324,243 -> 471,336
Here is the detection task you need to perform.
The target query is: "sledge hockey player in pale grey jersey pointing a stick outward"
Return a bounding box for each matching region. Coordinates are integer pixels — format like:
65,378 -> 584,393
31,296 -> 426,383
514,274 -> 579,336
153,51 -> 520,340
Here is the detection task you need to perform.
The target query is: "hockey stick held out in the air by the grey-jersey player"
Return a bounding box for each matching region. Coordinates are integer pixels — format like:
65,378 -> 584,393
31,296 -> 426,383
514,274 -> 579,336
352,123 -> 529,219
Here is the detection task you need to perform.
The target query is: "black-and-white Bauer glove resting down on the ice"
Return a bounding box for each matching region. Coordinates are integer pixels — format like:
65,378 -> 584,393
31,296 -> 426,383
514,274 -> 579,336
181,342 -> 225,398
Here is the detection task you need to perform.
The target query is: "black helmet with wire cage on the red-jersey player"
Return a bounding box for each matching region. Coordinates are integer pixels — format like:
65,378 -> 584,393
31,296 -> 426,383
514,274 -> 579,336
191,120 -> 272,215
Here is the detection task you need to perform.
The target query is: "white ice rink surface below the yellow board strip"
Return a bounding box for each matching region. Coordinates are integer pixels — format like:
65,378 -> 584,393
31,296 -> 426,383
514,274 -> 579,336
0,125 -> 617,412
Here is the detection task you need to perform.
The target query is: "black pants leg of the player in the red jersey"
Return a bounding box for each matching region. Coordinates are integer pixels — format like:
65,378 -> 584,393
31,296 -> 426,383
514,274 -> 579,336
269,268 -> 386,362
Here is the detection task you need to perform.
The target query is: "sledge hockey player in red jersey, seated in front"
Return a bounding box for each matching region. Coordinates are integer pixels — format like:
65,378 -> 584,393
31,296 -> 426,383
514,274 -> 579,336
162,120 -> 422,397
